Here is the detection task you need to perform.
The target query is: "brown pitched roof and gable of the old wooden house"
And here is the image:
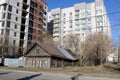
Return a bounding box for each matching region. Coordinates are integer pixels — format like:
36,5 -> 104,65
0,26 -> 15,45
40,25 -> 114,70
26,43 -> 67,59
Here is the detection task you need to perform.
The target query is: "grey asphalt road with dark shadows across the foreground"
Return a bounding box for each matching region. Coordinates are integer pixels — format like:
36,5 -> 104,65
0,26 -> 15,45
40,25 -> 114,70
0,69 -> 120,80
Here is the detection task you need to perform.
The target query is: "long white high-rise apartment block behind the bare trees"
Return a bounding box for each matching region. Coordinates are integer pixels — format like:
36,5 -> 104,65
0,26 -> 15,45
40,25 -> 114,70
48,0 -> 111,47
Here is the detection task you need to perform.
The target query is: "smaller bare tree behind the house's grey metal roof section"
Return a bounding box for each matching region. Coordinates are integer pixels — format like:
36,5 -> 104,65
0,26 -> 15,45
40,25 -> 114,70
66,34 -> 80,54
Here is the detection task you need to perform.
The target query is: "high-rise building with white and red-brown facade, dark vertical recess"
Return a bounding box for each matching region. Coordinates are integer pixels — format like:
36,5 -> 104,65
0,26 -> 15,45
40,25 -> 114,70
0,0 -> 48,55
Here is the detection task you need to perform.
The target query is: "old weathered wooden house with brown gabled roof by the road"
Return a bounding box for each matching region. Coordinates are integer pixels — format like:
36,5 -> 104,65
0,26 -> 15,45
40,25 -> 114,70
25,43 -> 76,68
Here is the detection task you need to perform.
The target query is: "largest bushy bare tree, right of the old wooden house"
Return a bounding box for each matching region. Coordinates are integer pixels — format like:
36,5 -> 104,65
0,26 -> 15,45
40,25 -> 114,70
80,32 -> 113,65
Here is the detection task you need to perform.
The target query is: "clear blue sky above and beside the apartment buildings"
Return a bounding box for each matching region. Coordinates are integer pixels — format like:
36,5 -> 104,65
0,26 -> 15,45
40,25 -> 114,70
45,0 -> 120,46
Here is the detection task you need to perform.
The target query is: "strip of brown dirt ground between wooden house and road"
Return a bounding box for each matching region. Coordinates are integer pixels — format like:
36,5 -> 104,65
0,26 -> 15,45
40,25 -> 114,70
0,63 -> 120,78
